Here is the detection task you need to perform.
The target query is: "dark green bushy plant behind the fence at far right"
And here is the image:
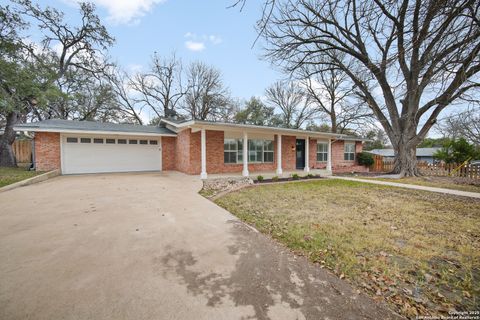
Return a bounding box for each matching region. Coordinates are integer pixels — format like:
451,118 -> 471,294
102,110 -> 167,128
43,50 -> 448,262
433,138 -> 480,164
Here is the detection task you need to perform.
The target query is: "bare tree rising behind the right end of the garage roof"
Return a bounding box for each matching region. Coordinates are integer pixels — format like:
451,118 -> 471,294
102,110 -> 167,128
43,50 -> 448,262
132,53 -> 186,117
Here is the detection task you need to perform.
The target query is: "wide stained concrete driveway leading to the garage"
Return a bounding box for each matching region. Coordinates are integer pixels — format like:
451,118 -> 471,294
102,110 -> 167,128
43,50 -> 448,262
0,173 -> 396,320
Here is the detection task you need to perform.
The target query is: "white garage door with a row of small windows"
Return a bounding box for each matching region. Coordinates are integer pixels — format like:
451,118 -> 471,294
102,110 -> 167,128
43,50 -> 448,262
62,135 -> 162,174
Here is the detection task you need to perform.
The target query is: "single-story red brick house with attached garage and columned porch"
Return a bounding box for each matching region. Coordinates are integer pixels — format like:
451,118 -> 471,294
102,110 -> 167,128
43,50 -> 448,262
15,119 -> 368,179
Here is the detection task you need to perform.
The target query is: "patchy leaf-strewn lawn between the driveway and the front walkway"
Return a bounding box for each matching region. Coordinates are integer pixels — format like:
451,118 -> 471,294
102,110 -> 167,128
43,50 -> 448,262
216,180 -> 480,317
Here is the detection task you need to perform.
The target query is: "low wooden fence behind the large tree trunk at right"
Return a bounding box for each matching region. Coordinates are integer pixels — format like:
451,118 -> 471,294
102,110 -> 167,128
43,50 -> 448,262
370,155 -> 480,179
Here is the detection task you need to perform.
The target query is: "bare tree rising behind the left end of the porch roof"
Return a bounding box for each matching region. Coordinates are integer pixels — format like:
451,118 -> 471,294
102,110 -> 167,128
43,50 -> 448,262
183,62 -> 230,120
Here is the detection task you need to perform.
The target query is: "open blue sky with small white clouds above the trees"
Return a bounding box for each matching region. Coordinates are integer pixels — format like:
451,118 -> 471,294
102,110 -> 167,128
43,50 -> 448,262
39,0 -> 283,105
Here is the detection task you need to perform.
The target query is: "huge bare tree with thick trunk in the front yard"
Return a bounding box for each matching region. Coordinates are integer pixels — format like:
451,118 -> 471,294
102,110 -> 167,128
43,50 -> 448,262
259,0 -> 480,176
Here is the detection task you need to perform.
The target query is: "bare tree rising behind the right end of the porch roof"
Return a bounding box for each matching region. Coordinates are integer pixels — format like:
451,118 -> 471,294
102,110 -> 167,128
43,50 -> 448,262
265,81 -> 318,129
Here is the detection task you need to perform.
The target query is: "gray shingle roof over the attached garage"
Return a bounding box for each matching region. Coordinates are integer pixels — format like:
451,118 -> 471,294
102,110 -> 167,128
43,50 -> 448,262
15,119 -> 175,135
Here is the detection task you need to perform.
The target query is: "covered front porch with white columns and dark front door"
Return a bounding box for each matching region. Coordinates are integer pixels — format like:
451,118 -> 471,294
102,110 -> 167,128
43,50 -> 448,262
197,127 -> 335,179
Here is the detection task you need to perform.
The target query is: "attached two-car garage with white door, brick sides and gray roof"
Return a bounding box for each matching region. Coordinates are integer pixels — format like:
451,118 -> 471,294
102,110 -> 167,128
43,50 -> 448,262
15,119 -> 177,174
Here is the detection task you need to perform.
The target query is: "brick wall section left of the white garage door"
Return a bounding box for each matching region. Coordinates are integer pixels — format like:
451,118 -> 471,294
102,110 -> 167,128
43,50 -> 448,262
34,132 -> 61,171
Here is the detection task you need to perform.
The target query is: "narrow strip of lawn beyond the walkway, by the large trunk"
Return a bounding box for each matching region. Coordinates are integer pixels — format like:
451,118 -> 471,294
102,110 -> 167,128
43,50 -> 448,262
357,176 -> 480,192
